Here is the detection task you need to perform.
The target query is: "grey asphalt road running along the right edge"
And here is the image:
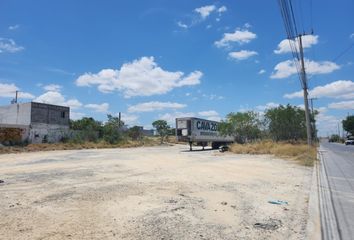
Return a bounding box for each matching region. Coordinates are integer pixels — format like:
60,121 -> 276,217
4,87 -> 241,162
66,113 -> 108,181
319,142 -> 354,239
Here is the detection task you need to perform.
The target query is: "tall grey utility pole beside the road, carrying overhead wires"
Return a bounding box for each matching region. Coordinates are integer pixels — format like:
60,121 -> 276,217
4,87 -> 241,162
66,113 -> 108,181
299,34 -> 312,146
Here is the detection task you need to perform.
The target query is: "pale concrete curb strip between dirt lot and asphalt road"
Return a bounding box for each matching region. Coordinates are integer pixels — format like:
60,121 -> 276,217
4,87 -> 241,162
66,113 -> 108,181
306,151 -> 322,240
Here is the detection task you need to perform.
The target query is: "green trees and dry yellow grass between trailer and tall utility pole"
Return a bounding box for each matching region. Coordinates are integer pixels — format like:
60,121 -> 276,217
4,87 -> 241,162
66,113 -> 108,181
219,104 -> 317,166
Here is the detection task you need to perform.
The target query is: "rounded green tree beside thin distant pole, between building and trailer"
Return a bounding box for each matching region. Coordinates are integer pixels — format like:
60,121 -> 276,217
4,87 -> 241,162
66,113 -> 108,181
103,114 -> 124,144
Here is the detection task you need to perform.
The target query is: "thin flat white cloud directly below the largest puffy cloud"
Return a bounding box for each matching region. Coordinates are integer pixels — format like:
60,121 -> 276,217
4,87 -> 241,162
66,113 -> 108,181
128,101 -> 186,112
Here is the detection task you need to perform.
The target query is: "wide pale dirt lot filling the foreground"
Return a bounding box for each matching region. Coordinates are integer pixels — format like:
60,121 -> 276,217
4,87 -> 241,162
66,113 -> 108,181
0,146 -> 312,240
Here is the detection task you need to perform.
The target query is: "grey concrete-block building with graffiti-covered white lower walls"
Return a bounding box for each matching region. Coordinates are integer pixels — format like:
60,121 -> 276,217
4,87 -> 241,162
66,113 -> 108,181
0,102 -> 70,144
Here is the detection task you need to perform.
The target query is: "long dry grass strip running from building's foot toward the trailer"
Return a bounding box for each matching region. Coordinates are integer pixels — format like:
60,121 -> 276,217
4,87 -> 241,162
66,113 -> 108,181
0,137 -> 160,154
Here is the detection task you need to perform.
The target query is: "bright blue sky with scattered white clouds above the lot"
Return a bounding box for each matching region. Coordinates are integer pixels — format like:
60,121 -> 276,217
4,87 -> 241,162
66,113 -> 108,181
0,0 -> 354,135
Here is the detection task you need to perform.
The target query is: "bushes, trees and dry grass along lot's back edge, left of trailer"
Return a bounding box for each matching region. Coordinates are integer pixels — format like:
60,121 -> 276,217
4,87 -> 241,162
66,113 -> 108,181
0,115 -> 176,154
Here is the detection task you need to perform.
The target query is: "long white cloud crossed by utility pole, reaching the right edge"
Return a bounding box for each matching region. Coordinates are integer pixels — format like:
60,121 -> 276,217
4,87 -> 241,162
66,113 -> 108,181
284,80 -> 354,99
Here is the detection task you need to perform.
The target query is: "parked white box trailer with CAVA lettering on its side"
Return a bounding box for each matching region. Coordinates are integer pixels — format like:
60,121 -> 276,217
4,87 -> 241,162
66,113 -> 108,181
176,117 -> 234,151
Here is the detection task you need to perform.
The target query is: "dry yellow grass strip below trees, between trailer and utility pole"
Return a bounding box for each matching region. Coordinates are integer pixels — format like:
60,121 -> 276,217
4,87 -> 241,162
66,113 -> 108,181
230,141 -> 317,166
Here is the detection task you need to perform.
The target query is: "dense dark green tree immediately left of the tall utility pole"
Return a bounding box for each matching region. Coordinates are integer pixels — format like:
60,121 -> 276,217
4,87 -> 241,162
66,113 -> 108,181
265,104 -> 306,141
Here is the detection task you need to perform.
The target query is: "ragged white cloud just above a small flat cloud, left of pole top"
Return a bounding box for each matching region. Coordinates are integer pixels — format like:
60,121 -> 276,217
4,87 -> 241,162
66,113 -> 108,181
214,29 -> 257,48
